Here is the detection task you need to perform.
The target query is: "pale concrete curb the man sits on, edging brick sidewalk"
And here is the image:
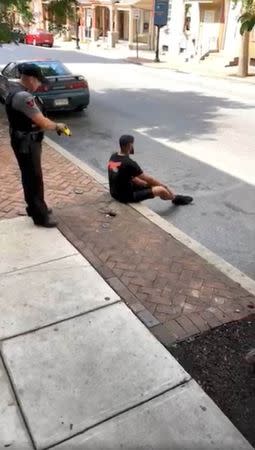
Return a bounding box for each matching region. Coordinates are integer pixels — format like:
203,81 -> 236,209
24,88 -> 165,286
45,137 -> 255,296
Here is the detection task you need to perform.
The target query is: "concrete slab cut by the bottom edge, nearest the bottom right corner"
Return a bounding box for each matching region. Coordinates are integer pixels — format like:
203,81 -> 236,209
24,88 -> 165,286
53,381 -> 252,450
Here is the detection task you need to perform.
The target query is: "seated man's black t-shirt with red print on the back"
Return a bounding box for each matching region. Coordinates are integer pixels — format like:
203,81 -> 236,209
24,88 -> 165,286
108,153 -> 143,202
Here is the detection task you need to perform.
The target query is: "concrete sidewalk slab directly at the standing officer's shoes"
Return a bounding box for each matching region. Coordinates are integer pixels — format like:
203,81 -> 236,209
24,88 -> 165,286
0,217 -> 78,274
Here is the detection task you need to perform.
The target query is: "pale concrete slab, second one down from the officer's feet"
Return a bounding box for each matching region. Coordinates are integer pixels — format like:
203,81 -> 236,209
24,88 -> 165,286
0,255 -> 119,339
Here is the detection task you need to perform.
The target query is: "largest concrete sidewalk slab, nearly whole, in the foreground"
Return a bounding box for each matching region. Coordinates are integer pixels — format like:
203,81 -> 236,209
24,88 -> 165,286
2,303 -> 190,449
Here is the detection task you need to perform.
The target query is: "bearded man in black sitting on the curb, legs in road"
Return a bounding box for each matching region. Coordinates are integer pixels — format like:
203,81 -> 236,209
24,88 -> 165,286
108,135 -> 193,205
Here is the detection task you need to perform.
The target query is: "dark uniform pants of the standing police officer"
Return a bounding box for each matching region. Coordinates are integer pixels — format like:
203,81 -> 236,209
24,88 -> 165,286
11,138 -> 48,224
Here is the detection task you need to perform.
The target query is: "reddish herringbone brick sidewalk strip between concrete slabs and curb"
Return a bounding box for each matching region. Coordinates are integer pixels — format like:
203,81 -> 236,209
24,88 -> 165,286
0,115 -> 255,344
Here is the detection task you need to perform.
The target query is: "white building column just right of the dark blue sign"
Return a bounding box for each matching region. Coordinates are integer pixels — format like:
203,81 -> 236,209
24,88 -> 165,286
169,0 -> 185,56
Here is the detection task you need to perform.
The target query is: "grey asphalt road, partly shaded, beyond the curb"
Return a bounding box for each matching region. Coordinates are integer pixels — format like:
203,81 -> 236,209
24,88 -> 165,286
0,46 -> 255,279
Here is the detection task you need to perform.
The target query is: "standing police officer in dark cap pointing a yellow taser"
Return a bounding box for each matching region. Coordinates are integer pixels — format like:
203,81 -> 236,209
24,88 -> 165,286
6,63 -> 65,228
